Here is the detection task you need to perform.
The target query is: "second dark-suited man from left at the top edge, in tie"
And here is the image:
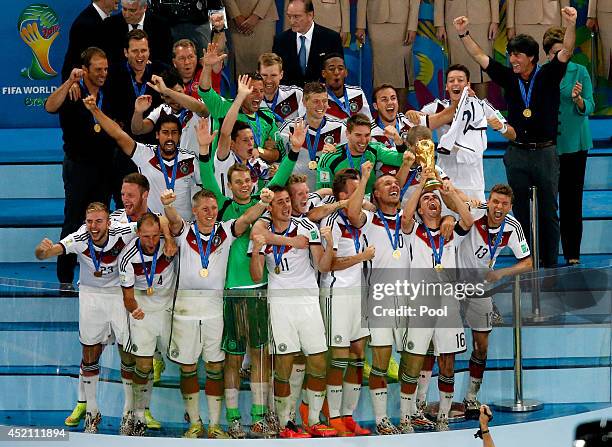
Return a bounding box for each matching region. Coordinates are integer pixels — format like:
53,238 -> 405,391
103,0 -> 172,66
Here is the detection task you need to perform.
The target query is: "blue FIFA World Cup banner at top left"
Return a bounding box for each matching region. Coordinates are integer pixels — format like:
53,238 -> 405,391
0,0 -> 89,128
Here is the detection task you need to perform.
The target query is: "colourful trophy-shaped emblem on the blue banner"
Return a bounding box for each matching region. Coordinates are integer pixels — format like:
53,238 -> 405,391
17,3 -> 60,80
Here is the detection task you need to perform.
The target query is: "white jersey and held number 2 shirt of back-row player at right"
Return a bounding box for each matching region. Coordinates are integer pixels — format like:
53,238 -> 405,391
424,88 -> 506,192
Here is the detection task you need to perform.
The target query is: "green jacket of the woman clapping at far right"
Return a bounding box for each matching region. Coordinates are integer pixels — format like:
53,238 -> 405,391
557,62 -> 595,154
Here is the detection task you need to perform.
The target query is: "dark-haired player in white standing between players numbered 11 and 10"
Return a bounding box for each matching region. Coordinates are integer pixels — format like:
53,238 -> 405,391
320,168 -> 376,436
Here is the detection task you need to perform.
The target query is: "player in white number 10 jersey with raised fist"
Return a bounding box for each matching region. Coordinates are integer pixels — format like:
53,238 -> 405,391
348,161 -> 410,435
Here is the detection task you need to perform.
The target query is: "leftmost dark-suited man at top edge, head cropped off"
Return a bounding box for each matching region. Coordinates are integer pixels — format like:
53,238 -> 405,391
62,0 -> 119,81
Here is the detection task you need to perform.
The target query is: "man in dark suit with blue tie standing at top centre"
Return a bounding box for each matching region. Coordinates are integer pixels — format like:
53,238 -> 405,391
272,0 -> 344,87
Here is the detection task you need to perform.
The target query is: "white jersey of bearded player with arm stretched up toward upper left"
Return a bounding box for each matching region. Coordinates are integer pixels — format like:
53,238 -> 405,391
132,143 -> 201,221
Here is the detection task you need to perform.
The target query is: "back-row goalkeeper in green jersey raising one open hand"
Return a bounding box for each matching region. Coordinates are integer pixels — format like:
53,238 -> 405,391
199,44 -> 280,163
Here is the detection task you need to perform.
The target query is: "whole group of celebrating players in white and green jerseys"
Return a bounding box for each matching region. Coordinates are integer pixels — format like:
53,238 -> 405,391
36,2 -> 544,438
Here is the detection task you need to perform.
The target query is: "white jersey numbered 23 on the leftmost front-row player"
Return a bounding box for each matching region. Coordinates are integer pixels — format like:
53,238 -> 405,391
59,224 -> 136,287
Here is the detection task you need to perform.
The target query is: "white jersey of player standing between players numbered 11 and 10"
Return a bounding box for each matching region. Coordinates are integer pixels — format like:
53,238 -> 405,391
321,211 -> 365,288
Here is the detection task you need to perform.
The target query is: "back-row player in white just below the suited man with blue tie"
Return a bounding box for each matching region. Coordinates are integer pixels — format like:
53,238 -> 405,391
321,53 -> 372,122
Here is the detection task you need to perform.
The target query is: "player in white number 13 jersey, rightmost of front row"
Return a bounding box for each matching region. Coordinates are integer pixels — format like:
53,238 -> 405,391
460,184 -> 533,418
